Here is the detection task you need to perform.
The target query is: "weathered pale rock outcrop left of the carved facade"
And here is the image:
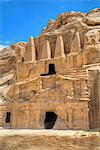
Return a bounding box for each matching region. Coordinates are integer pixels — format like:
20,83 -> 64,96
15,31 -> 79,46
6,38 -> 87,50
0,42 -> 26,102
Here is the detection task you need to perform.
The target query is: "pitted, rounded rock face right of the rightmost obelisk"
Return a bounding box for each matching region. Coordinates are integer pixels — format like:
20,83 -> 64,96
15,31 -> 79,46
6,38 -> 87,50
83,29 -> 100,64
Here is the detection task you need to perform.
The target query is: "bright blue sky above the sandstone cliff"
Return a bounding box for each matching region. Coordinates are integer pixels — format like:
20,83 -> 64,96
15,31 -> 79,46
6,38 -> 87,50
0,0 -> 100,45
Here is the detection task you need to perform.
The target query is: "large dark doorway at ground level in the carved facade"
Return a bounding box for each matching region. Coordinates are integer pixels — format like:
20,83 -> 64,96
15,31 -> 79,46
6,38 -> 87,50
44,112 -> 57,129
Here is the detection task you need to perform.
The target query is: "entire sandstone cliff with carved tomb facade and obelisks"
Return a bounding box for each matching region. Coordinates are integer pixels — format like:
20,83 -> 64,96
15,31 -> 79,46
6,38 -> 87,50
0,9 -> 100,130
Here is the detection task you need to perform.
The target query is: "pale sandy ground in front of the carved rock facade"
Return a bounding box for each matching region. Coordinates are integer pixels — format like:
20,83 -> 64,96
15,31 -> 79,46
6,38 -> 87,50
0,128 -> 100,150
